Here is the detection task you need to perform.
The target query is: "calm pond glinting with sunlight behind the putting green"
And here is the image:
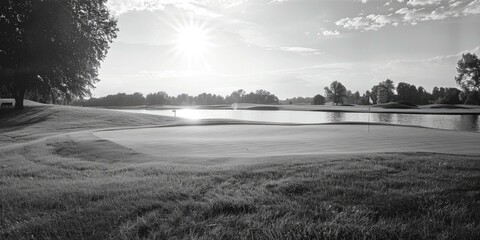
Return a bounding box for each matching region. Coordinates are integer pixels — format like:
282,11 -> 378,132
118,109 -> 480,132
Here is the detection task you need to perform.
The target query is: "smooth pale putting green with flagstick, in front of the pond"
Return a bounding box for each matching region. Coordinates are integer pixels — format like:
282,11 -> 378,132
94,125 -> 480,158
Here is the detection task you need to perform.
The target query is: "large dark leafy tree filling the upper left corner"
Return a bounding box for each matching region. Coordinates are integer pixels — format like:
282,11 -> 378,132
0,0 -> 118,109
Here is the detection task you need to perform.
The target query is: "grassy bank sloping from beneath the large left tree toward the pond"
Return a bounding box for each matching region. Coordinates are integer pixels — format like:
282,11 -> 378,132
0,104 -> 176,146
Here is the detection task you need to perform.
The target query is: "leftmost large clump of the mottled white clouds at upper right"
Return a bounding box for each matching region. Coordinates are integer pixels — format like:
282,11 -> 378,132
335,14 -> 391,31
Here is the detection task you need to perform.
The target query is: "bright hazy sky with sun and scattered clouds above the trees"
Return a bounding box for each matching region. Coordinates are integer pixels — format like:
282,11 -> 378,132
93,0 -> 480,99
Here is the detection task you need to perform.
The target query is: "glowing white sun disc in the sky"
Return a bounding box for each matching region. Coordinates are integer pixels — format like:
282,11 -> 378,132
175,23 -> 210,58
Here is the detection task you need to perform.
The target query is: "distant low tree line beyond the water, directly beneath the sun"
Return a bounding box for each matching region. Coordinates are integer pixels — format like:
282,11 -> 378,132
72,89 -> 279,107
